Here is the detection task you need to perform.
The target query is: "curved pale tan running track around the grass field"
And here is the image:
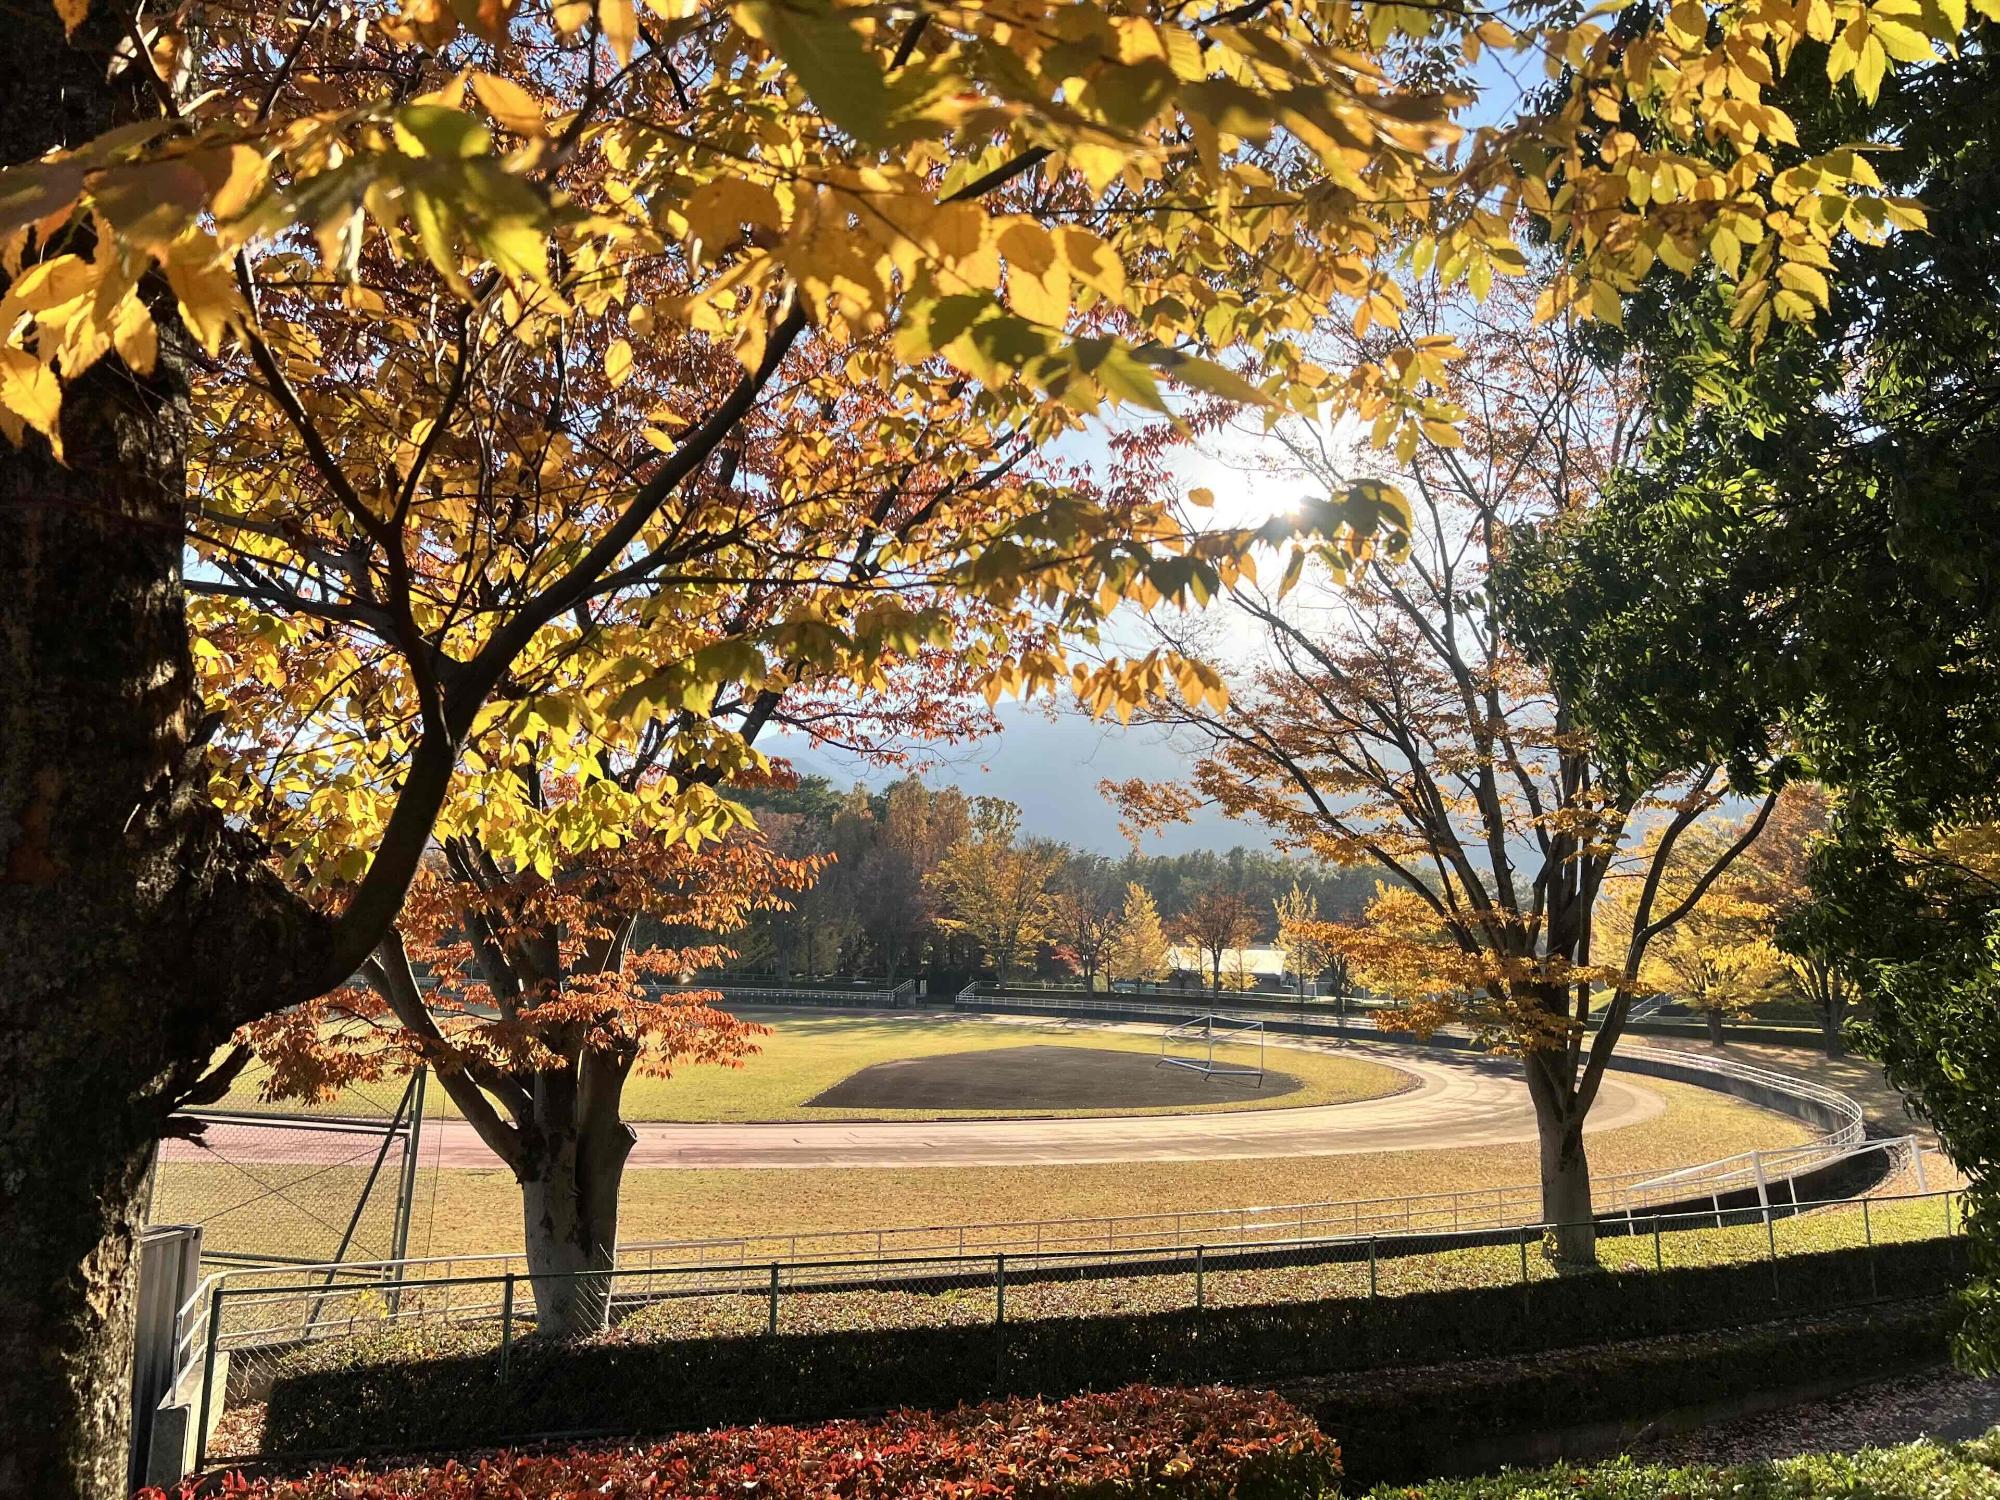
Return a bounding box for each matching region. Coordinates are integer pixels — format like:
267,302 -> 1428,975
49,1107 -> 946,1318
290,1038 -> 1666,1168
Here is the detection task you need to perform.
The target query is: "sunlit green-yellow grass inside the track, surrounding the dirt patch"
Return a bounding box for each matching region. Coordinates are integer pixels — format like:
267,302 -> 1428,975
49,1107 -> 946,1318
220,1010 -> 1408,1122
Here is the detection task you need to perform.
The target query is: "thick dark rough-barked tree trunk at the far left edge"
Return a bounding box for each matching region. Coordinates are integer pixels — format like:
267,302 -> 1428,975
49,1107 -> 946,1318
0,14 -> 330,1500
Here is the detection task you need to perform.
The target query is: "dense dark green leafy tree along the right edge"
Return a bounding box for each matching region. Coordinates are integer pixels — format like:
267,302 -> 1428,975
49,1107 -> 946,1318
1514,24 -> 2000,1368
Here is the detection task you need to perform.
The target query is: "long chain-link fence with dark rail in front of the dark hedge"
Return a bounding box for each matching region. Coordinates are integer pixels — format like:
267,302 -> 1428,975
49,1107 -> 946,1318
180,1192 -> 1964,1462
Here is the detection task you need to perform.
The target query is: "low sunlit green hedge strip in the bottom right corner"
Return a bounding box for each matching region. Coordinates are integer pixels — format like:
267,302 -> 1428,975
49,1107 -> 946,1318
1370,1432 -> 2000,1500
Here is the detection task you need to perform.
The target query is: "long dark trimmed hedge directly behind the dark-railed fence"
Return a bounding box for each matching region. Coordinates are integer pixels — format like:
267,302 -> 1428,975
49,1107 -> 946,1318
264,1240 -> 1964,1454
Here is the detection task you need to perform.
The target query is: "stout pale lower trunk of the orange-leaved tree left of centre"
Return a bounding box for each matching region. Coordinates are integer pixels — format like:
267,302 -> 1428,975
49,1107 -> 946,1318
520,1124 -> 636,1338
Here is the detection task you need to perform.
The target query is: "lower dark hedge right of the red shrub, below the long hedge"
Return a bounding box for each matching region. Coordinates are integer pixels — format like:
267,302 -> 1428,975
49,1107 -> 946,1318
1284,1298 -> 1954,1486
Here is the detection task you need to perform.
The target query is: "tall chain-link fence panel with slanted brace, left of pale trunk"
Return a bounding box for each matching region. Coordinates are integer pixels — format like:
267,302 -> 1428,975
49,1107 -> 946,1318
146,1072 -> 424,1268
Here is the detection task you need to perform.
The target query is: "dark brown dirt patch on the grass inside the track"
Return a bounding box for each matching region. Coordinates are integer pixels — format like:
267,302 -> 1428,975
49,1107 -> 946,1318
806,1046 -> 1304,1110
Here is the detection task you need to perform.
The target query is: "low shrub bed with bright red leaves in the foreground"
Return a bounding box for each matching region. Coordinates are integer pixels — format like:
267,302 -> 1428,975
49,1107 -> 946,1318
140,1386 -> 1340,1500
